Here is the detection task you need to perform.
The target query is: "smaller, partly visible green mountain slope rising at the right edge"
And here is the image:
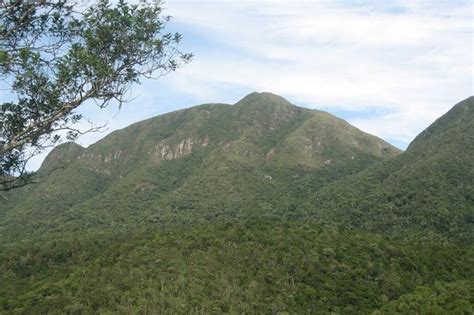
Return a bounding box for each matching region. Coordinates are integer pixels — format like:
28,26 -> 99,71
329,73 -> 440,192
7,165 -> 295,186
310,97 -> 474,242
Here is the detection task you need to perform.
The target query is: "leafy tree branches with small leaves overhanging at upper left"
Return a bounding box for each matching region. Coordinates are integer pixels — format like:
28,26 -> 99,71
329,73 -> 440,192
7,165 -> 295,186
0,0 -> 192,190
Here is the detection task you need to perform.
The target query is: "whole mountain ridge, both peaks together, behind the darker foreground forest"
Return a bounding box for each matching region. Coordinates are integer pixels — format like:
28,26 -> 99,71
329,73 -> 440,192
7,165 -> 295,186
0,93 -> 474,244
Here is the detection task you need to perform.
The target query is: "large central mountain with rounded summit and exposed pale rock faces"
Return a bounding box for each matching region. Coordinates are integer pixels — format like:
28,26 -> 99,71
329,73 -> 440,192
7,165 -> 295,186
0,93 -> 400,241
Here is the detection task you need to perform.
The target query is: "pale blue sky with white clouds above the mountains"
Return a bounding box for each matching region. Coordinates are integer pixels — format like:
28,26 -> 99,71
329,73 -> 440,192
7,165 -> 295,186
26,0 -> 474,169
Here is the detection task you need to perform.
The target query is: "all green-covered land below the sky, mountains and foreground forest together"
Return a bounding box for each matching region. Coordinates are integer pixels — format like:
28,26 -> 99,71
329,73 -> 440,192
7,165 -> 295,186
0,93 -> 474,314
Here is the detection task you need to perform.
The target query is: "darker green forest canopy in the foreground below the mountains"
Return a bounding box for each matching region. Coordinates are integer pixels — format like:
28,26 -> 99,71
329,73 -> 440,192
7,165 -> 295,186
0,220 -> 473,314
